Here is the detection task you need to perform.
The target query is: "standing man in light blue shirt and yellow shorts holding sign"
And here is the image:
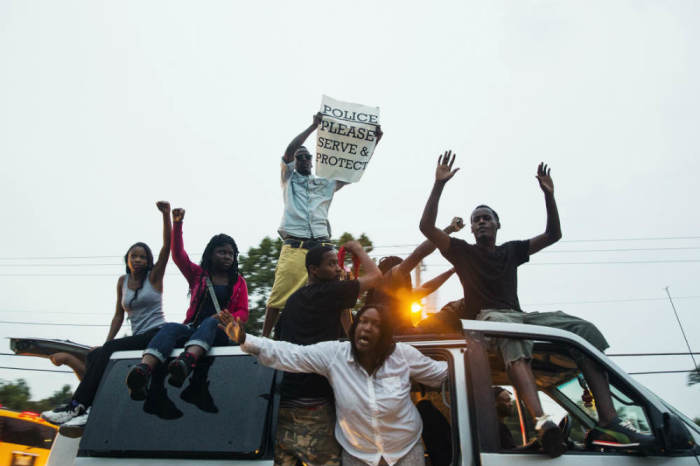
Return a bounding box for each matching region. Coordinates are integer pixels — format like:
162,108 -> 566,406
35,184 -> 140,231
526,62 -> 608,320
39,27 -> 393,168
263,112 -> 382,337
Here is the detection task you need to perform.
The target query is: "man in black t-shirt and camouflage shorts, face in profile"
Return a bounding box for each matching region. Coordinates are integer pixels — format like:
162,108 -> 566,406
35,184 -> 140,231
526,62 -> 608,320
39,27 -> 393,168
268,241 -> 381,465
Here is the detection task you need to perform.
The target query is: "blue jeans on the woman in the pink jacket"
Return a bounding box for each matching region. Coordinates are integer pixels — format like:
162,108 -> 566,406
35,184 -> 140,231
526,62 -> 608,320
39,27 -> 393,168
143,316 -> 229,362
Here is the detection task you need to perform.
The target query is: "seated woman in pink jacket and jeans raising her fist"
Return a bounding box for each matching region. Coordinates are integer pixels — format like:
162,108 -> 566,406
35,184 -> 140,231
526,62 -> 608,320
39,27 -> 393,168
126,209 -> 248,400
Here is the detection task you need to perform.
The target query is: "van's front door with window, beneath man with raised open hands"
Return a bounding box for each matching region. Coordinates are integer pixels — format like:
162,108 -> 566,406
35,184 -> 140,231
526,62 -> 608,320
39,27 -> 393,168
465,331 -> 698,466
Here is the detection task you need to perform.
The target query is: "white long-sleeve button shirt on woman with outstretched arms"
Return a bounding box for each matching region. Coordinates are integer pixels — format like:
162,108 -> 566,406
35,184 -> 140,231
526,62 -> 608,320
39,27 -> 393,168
241,335 -> 447,466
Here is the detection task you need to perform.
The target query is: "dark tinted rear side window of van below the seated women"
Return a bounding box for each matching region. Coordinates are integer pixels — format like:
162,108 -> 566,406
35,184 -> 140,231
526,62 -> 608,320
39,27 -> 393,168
78,355 -> 274,458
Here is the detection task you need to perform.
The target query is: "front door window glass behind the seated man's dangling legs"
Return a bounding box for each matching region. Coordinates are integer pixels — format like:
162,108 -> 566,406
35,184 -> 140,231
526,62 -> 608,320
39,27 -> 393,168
469,337 -> 652,454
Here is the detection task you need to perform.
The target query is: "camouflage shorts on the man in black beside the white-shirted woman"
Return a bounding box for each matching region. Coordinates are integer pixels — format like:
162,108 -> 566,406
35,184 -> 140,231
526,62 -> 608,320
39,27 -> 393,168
275,403 -> 341,466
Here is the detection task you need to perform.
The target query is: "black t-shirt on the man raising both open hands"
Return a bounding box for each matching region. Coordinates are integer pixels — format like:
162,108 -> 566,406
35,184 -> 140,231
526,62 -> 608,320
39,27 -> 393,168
443,238 -> 530,319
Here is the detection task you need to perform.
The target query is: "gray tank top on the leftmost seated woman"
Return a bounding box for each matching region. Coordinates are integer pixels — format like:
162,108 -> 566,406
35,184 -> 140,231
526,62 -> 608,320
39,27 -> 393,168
122,272 -> 165,335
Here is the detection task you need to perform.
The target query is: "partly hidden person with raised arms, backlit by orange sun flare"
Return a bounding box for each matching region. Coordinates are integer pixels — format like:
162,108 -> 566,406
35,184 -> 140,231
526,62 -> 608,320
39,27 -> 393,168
366,217 -> 464,335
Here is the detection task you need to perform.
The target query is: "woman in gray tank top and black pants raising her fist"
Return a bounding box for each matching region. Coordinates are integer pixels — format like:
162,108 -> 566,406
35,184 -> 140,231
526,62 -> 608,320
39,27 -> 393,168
41,201 -> 172,437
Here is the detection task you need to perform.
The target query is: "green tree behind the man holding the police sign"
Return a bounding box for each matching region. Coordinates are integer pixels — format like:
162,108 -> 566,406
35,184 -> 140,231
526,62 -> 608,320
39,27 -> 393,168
238,232 -> 372,335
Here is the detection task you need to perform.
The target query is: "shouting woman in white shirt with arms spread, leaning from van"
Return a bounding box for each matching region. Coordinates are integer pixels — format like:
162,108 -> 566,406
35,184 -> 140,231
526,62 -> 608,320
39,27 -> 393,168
220,306 -> 448,466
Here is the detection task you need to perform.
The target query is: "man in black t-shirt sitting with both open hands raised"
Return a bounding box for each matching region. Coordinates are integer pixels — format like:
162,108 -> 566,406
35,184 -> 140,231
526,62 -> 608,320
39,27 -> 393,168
420,151 -> 650,457
